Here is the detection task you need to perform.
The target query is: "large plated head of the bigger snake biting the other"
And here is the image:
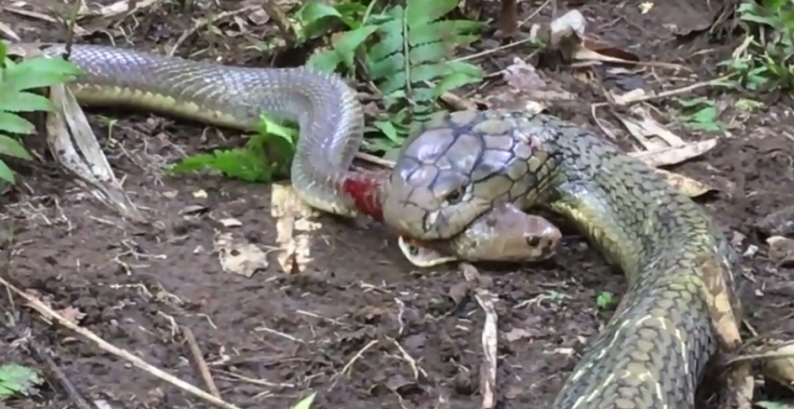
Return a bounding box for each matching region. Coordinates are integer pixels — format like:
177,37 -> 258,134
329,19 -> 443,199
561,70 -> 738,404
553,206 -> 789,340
383,111 -> 536,240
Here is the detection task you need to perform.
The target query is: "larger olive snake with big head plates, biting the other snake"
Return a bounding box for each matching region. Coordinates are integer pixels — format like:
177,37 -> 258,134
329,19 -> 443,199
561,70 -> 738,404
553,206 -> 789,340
383,111 -> 741,409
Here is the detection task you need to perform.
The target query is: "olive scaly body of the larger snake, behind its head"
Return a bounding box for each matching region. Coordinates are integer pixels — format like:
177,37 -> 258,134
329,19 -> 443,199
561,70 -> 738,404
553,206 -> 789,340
534,114 -> 741,409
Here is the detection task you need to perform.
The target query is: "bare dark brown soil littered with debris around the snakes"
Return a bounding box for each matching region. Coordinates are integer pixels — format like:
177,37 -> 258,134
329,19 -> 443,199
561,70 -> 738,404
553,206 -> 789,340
0,1 -> 794,409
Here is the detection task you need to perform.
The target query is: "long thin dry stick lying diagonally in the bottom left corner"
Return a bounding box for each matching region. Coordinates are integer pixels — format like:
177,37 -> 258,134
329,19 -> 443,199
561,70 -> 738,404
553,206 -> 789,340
0,277 -> 240,409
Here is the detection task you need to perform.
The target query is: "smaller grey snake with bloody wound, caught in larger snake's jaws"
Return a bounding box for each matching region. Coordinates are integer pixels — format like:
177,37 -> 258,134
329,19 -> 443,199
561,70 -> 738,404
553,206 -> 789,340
17,44 -> 562,267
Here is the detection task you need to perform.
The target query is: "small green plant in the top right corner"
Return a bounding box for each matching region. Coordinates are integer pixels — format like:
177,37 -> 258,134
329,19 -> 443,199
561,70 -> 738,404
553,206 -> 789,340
722,0 -> 794,91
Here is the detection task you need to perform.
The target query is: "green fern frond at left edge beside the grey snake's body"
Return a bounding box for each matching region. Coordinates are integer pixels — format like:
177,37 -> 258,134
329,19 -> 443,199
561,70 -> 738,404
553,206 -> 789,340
0,42 -> 80,184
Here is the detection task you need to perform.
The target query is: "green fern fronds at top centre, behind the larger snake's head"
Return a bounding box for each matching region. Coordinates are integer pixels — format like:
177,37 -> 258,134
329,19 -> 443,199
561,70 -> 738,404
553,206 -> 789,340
297,0 -> 482,152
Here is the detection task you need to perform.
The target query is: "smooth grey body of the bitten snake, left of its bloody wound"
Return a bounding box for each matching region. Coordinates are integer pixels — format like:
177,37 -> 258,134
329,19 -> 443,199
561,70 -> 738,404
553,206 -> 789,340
45,45 -> 364,216
